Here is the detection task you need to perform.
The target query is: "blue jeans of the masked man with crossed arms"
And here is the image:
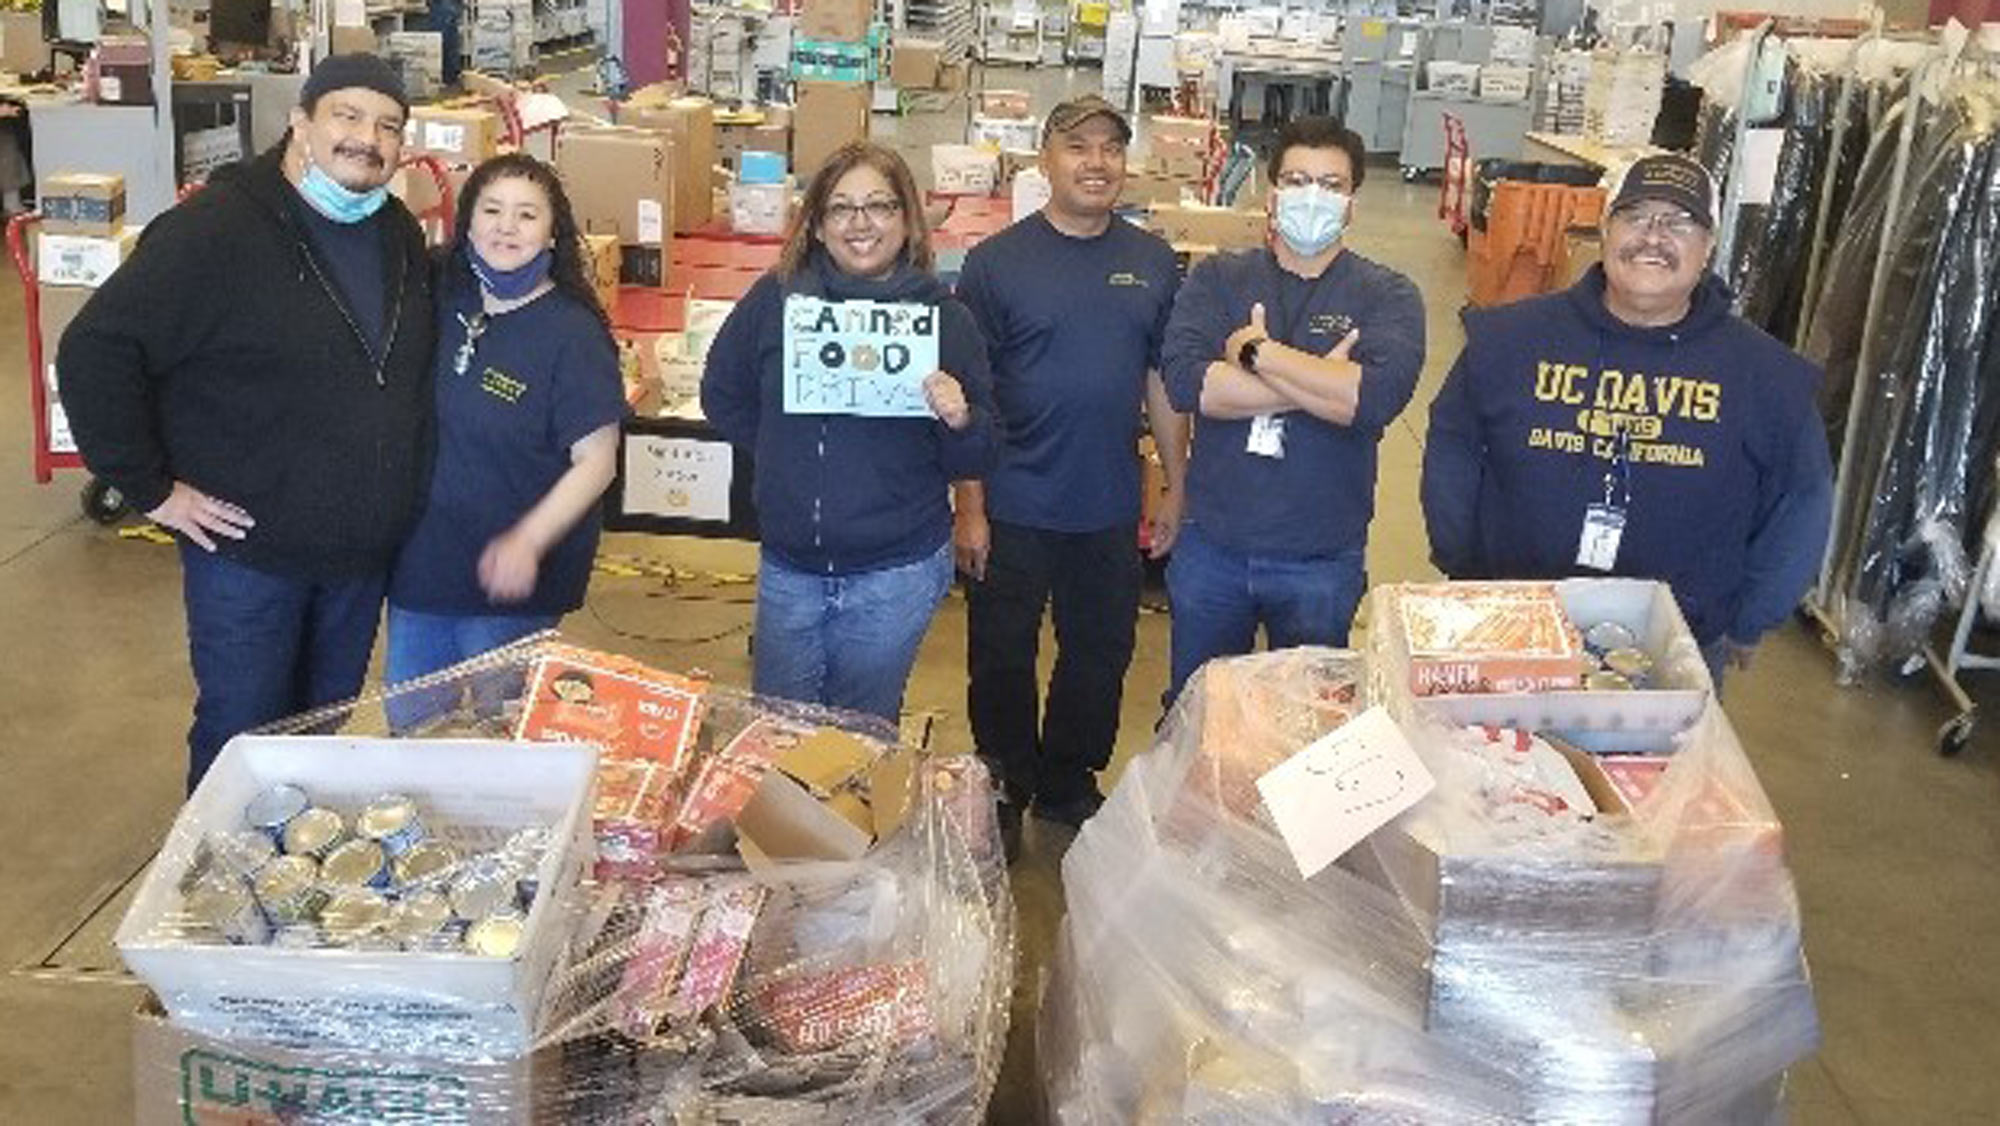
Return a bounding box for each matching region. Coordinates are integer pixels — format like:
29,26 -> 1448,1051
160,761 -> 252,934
1166,522 -> 1368,708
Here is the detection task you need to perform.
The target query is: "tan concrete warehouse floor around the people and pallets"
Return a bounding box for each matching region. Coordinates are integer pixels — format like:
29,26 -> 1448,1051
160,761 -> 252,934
0,68 -> 2000,1126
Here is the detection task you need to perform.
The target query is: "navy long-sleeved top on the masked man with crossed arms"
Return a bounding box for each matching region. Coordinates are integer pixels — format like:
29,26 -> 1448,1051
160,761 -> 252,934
1160,250 -> 1424,558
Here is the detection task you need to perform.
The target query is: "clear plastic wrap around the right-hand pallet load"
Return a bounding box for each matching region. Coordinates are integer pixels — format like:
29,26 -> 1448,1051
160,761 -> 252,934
1038,648 -> 1818,1126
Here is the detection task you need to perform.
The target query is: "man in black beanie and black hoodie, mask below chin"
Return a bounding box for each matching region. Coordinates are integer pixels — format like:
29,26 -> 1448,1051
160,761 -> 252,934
56,54 -> 434,790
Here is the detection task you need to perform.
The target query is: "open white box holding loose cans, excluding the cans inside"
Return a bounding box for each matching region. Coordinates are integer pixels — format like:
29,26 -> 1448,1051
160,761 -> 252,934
116,736 -> 598,1056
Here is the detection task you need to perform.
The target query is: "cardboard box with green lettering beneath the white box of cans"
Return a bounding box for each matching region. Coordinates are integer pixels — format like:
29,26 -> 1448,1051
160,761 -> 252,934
132,994 -> 562,1126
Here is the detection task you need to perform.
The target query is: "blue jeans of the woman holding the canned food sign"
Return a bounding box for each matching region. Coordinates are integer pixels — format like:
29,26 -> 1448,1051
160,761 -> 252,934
754,544 -> 952,722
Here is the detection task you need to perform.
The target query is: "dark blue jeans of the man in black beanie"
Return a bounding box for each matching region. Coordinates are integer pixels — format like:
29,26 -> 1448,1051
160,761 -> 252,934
180,540 -> 388,794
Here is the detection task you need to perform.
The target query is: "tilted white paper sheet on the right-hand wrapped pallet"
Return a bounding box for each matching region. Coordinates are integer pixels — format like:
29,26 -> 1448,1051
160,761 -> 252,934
1256,706 -> 1438,880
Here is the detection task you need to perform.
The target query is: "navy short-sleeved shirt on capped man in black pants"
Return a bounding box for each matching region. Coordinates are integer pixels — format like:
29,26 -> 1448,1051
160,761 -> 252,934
958,212 -> 1180,532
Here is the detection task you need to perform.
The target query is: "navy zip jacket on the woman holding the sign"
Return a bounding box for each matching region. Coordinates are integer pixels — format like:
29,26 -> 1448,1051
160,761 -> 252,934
702,254 -> 1000,574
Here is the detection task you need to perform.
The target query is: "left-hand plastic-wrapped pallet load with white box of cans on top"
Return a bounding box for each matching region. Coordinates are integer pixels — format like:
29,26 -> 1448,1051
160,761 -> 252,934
118,634 -> 1014,1124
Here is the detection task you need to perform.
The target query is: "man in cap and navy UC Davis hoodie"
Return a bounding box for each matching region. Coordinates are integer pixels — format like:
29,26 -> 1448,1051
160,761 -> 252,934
1422,154 -> 1832,684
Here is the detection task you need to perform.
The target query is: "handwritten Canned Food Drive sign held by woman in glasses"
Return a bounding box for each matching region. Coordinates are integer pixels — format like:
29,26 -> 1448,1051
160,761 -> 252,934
784,294 -> 938,418
